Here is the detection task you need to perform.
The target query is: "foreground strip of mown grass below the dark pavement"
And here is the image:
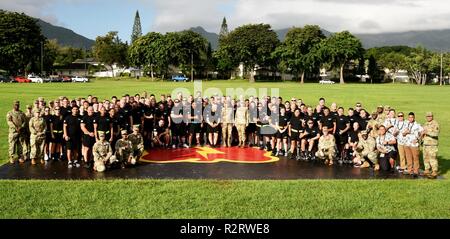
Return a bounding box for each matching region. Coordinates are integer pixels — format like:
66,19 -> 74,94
0,180 -> 450,218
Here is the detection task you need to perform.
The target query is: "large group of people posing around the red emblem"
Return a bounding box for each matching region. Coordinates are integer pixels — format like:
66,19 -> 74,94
7,92 -> 439,178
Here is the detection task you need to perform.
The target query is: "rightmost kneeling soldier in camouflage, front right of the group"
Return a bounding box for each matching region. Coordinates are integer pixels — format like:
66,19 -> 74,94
354,130 -> 380,171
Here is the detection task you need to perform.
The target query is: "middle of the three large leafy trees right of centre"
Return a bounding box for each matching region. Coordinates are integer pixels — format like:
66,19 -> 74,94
274,25 -> 325,84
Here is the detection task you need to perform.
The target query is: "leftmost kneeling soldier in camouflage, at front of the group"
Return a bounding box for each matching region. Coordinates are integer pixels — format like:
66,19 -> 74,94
92,132 -> 115,172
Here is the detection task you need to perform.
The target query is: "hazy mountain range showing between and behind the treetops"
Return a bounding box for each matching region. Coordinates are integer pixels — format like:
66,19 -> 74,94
38,19 -> 450,51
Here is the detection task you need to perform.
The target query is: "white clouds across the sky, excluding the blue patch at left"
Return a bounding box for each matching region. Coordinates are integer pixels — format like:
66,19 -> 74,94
0,0 -> 450,33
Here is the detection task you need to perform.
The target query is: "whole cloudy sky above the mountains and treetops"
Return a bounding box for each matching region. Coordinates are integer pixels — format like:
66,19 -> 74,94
0,0 -> 450,40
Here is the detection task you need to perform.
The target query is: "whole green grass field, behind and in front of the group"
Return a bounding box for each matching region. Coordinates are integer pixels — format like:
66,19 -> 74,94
0,79 -> 450,218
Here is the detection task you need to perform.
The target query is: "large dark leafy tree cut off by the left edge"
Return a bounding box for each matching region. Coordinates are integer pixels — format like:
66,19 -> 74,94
0,10 -> 45,73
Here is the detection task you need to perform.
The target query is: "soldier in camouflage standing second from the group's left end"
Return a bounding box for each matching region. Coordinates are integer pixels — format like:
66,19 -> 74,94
29,109 -> 47,165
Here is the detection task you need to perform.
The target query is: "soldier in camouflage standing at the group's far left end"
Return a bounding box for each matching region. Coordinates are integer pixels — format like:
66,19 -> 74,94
6,101 -> 26,164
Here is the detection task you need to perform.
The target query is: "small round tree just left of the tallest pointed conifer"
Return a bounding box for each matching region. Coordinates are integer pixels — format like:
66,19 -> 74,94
94,32 -> 128,76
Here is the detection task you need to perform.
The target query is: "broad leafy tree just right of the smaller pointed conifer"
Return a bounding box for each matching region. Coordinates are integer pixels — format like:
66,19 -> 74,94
217,24 -> 280,82
